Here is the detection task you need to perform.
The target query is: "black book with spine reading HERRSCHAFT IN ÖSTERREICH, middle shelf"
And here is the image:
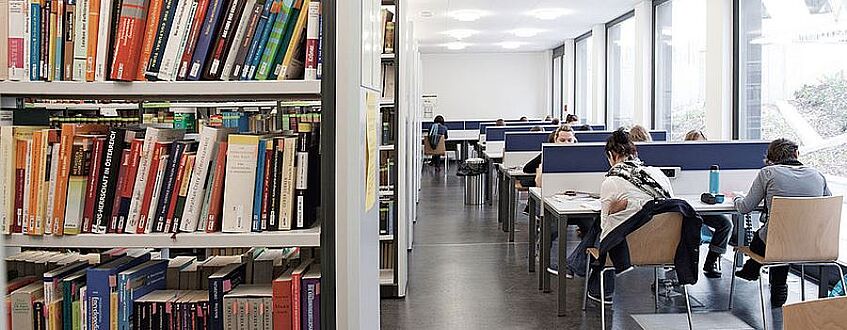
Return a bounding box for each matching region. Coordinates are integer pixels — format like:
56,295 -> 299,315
92,128 -> 126,234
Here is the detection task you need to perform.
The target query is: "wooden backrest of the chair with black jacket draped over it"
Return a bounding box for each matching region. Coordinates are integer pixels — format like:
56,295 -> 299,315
626,213 -> 682,266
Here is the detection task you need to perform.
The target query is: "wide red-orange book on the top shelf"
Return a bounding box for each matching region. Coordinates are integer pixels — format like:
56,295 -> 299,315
110,0 -> 149,81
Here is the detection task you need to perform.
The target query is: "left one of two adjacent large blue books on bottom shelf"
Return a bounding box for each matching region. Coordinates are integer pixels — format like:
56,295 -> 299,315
85,253 -> 150,330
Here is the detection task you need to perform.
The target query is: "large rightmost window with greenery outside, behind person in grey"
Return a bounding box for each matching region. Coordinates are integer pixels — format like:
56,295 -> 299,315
735,0 -> 847,194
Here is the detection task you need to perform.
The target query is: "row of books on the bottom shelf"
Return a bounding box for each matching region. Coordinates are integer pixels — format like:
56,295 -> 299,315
3,248 -> 321,330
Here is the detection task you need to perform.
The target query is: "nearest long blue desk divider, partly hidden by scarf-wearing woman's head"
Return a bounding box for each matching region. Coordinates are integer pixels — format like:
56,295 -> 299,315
542,141 -> 768,173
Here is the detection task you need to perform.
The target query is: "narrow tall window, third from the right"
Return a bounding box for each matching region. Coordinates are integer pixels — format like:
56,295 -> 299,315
606,12 -> 635,128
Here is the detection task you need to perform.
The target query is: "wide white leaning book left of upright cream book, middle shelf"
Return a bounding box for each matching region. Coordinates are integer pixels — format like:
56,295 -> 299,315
179,127 -> 231,232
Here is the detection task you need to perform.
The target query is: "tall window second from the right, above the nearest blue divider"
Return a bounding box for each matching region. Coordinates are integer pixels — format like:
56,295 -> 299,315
653,0 -> 707,140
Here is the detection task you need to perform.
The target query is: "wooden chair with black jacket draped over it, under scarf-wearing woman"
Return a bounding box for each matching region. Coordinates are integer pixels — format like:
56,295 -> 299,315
582,213 -> 694,329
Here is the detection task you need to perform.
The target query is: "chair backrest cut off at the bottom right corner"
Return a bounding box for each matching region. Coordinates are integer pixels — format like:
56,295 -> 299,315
782,297 -> 847,330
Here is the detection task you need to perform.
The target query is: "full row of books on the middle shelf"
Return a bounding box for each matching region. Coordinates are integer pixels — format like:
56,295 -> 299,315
0,111 -> 320,235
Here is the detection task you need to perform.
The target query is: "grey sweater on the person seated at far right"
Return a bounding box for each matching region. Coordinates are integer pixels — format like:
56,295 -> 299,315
734,165 -> 832,242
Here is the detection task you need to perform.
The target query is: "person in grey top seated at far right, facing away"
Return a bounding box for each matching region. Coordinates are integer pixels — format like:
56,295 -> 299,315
730,139 -> 832,307
